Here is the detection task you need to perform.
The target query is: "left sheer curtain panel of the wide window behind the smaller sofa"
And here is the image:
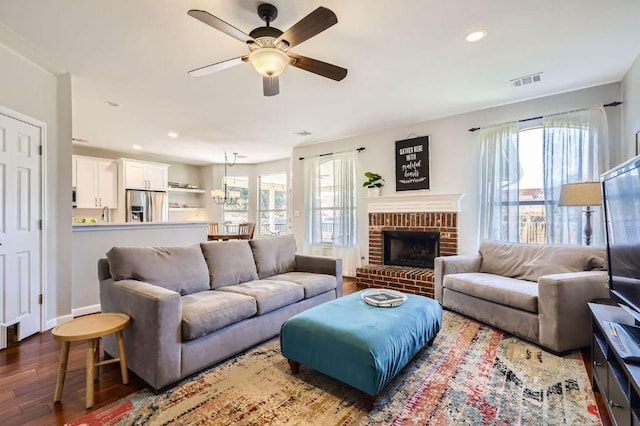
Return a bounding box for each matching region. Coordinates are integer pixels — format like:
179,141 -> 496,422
478,122 -> 521,241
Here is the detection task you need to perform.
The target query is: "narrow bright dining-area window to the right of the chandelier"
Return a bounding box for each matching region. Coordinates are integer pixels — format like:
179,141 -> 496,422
258,173 -> 288,235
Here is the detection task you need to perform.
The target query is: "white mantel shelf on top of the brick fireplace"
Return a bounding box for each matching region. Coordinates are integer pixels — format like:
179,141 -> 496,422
367,194 -> 464,213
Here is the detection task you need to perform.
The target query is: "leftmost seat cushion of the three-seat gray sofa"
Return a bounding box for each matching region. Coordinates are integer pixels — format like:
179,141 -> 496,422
180,290 -> 257,340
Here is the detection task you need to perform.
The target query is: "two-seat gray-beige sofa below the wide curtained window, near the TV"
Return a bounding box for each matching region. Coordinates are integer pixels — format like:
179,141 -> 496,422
434,241 -> 609,352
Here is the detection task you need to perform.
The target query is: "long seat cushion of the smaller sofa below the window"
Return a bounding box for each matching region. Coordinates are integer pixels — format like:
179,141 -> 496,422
443,272 -> 538,314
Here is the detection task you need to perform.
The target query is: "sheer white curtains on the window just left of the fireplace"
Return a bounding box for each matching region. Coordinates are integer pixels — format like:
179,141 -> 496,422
302,151 -> 360,277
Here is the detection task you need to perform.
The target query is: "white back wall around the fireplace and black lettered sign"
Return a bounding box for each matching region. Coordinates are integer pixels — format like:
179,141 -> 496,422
291,83 -> 621,263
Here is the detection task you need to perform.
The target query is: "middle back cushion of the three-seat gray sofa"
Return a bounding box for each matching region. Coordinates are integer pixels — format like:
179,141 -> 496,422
200,240 -> 258,289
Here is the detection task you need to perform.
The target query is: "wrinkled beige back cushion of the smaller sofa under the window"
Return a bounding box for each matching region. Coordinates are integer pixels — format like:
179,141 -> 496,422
479,241 -> 606,281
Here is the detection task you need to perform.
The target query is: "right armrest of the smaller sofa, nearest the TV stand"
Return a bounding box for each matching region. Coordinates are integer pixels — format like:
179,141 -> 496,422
538,271 -> 609,352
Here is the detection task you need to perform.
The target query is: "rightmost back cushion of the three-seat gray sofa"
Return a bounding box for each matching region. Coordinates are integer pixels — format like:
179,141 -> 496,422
249,235 -> 296,279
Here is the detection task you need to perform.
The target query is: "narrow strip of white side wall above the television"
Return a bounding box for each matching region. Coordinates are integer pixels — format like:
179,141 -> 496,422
622,55 -> 640,160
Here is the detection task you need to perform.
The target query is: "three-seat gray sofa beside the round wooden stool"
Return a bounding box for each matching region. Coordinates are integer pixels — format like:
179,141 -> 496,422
98,235 -> 342,391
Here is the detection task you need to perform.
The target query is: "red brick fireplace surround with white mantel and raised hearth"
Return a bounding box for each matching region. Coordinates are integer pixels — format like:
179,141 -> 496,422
356,194 -> 461,297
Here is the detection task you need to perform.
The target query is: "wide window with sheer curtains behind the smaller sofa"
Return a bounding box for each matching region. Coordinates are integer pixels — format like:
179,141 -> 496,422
479,107 -> 607,244
